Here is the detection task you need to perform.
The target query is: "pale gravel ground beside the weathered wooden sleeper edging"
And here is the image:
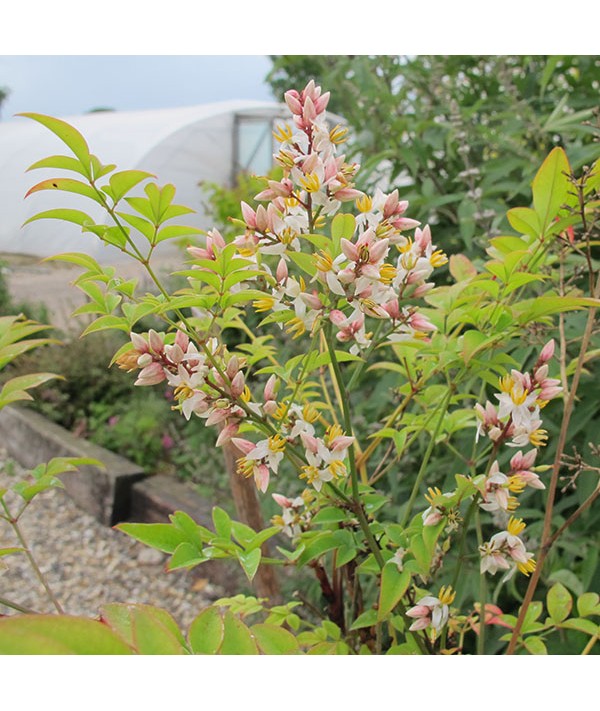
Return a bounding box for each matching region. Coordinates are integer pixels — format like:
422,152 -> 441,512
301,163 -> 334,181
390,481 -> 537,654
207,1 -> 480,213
0,450 -> 223,628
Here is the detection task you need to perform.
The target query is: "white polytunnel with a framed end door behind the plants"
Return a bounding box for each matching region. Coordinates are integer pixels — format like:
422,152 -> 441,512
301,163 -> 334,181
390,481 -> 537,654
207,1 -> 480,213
0,101 -> 287,261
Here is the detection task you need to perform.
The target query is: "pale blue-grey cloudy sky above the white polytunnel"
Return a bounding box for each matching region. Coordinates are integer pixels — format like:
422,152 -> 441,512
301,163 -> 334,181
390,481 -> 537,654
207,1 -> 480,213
0,55 -> 273,121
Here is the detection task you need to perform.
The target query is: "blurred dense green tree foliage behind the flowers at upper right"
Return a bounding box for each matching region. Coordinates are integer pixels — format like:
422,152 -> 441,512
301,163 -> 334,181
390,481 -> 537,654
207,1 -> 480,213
267,55 -> 600,257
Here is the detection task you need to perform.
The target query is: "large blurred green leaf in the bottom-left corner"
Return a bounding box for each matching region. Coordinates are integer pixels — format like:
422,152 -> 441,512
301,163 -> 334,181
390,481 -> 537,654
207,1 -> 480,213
0,615 -> 132,655
